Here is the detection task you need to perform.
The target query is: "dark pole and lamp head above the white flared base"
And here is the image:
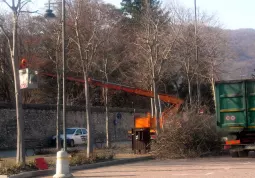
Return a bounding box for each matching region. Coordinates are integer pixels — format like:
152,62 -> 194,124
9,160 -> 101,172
44,0 -> 67,151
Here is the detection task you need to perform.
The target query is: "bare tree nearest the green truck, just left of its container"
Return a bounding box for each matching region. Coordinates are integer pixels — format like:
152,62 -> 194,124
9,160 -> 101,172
198,25 -> 228,106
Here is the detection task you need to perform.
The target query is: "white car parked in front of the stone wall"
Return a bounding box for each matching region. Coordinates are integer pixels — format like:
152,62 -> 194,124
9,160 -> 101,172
51,127 -> 87,147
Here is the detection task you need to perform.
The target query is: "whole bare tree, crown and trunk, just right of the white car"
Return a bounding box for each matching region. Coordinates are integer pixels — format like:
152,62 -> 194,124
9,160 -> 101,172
69,0 -> 106,157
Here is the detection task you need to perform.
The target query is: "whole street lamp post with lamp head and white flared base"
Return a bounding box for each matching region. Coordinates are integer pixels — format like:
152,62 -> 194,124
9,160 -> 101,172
45,0 -> 73,178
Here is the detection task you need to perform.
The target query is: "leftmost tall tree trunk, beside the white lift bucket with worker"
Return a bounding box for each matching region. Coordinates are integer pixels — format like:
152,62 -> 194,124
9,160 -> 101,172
11,12 -> 25,164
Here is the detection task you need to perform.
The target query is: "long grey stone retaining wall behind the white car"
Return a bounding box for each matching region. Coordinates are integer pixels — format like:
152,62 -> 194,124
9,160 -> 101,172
0,104 -> 146,149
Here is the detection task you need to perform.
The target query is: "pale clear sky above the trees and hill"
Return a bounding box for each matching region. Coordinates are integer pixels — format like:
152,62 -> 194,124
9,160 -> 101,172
3,0 -> 255,29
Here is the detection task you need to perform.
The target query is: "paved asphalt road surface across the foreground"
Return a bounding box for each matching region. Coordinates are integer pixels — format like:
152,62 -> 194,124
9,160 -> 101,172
43,157 -> 255,178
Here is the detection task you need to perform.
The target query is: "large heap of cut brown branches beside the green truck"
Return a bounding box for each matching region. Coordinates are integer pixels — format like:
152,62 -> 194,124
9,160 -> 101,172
152,112 -> 222,158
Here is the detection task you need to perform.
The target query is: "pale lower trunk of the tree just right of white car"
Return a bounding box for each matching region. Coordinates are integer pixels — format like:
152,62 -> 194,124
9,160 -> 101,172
83,71 -> 93,158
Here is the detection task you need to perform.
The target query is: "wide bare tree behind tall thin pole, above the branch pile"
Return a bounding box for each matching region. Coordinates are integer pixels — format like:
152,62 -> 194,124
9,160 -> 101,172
171,5 -> 225,105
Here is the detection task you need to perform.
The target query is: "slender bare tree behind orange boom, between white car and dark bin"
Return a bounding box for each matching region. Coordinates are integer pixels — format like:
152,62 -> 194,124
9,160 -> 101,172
93,5 -> 125,147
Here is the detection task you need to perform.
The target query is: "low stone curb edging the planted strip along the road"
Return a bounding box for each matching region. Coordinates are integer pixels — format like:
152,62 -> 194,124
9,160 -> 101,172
0,156 -> 153,178
